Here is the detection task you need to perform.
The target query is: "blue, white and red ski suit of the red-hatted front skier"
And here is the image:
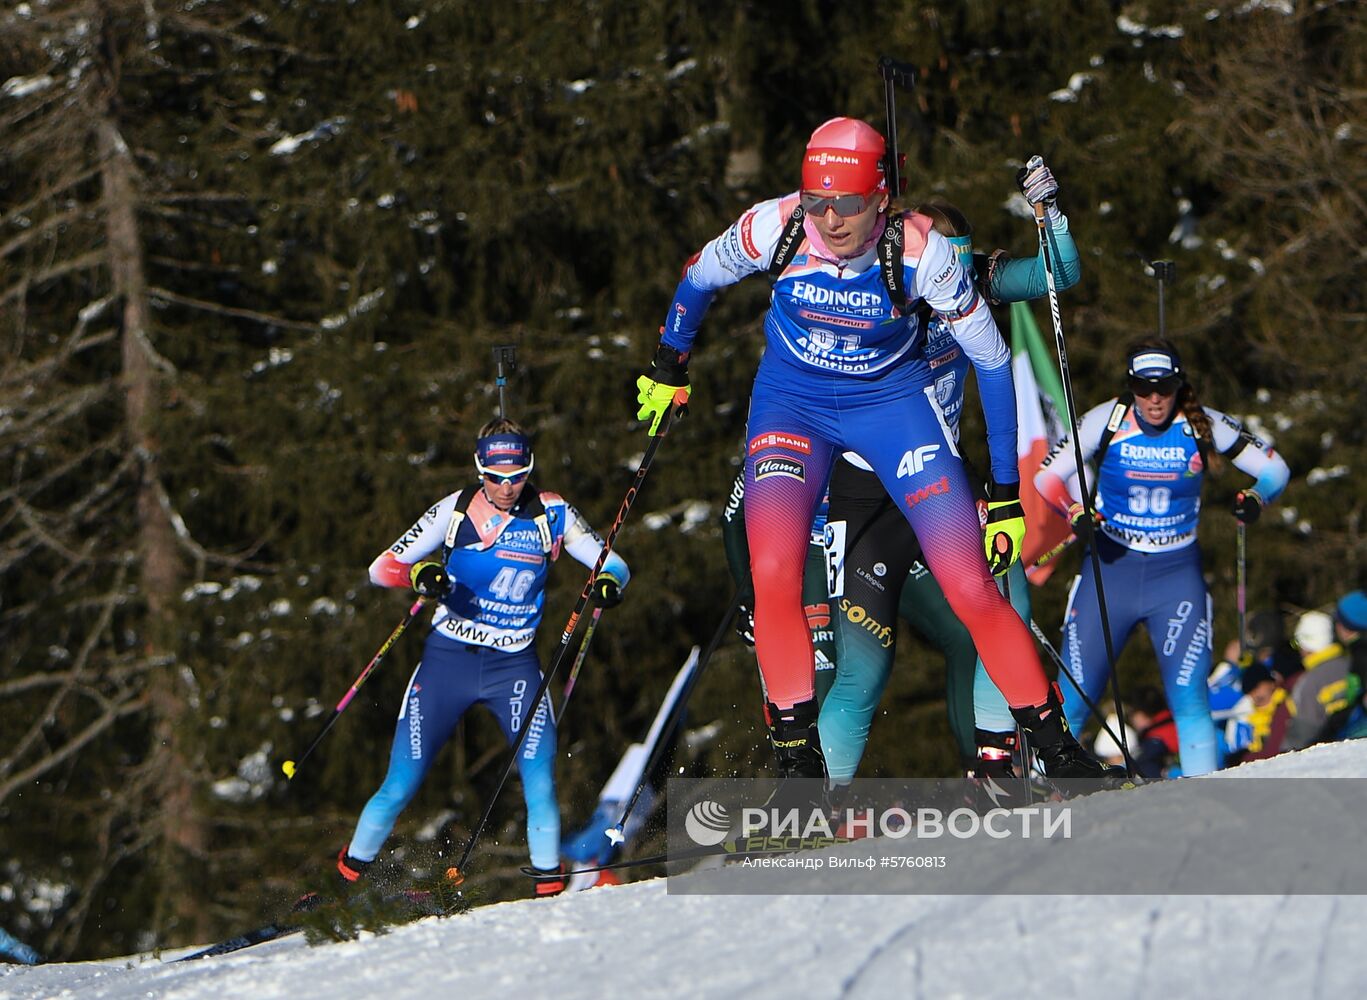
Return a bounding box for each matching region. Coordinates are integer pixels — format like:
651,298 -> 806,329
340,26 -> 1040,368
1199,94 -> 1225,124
663,193 -> 1048,708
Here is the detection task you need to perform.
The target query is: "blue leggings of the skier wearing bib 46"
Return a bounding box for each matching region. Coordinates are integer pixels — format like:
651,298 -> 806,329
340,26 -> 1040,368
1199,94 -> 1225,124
347,633 -> 560,869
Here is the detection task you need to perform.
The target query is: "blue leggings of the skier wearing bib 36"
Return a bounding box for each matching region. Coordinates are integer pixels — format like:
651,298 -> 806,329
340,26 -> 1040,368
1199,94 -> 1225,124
1062,536 -> 1219,775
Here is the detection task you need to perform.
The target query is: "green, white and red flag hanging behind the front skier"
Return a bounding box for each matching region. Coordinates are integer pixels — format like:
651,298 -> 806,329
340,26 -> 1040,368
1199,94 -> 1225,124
1012,302 -> 1072,586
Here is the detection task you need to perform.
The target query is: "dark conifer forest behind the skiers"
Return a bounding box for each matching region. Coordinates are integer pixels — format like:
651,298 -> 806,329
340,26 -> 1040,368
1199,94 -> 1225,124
0,0 -> 1367,958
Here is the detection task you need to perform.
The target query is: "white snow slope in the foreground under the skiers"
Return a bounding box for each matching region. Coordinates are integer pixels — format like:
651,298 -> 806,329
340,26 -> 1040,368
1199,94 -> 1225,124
10,740 -> 1367,1000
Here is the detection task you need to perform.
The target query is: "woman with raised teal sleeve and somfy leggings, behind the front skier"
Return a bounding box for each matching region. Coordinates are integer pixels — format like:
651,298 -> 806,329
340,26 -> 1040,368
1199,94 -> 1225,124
820,173 -> 1081,788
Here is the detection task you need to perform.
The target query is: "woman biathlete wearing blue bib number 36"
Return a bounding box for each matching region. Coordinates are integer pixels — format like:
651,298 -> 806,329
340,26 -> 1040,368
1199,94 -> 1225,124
1035,337 -> 1289,775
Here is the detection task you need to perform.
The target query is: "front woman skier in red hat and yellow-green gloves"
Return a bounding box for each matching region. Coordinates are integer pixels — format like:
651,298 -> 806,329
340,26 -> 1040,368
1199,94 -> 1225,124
637,117 -> 1106,779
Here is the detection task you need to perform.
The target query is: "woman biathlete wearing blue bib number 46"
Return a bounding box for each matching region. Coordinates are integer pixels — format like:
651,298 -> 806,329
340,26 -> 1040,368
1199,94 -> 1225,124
338,418 -> 630,896
